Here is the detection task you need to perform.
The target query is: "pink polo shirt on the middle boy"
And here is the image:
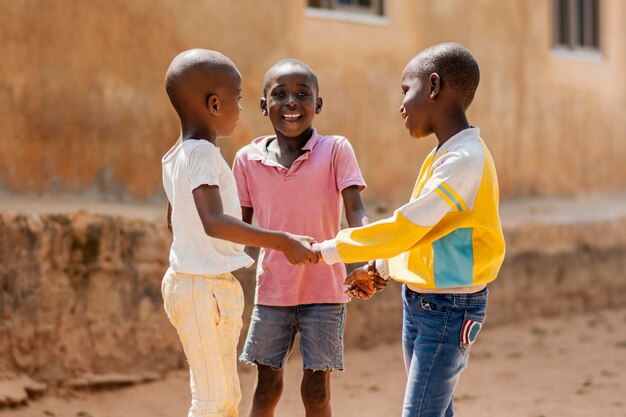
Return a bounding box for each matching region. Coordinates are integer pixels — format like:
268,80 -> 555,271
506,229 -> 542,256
233,130 -> 365,306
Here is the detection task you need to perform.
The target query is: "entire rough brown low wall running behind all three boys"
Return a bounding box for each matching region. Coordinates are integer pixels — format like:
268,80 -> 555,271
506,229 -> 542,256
0,197 -> 626,385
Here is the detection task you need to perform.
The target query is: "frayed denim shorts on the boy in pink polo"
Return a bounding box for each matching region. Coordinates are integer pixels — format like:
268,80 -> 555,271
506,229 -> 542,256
239,304 -> 346,371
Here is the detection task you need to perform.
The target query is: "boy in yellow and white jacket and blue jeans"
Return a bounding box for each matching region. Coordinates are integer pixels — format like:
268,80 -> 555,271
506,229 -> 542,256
317,43 -> 504,417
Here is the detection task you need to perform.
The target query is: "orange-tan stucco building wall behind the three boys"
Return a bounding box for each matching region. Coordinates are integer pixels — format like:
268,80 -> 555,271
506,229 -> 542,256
0,0 -> 626,209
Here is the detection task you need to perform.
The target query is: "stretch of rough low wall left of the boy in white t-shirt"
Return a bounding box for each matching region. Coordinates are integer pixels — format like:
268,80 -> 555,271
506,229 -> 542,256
0,212 -> 176,381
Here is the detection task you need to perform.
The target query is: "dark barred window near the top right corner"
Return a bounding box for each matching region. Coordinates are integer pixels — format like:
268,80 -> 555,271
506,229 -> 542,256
553,0 -> 600,51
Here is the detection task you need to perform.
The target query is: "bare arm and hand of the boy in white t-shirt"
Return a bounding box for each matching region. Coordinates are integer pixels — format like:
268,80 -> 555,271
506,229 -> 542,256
193,185 -> 317,264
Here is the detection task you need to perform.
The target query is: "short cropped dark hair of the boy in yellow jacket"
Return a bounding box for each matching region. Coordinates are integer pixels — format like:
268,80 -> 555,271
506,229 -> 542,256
413,42 -> 480,108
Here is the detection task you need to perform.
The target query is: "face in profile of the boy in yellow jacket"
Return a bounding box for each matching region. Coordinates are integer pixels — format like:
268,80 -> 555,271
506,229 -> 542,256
400,61 -> 438,139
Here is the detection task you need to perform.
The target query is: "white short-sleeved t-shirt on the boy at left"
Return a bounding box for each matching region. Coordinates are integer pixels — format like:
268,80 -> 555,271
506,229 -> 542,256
161,139 -> 253,275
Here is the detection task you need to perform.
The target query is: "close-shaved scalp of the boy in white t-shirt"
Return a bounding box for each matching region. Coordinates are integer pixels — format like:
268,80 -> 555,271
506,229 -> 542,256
165,49 -> 241,118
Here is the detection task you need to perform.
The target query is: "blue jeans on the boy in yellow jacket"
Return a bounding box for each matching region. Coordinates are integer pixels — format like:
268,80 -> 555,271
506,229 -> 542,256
402,285 -> 489,417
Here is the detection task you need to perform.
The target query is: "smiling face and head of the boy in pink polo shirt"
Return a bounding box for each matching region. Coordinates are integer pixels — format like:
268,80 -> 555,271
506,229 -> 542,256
261,64 -> 322,138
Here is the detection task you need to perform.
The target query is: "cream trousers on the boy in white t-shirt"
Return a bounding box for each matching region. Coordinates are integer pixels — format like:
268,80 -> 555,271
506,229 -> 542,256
161,269 -> 243,417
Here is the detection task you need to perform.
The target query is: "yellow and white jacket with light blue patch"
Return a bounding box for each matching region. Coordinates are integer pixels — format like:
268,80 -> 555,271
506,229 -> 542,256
320,128 -> 505,289
